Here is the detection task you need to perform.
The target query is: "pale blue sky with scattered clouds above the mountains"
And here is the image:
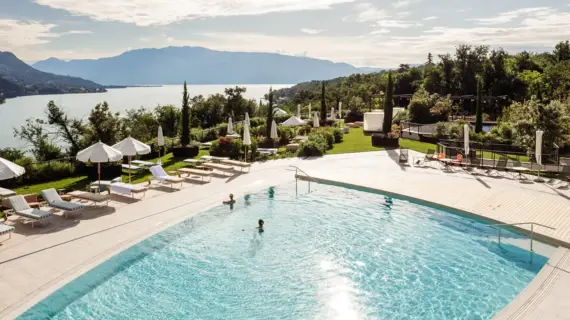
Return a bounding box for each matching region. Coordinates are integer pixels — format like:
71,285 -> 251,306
0,0 -> 570,68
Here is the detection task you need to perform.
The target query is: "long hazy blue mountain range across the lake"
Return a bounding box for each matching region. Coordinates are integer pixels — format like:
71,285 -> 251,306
33,47 -> 377,85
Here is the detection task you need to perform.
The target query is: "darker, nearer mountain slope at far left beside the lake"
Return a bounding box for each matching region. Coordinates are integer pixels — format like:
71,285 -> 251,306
0,51 -> 105,98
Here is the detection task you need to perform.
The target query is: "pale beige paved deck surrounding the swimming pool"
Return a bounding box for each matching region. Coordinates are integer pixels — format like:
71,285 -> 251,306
0,151 -> 570,319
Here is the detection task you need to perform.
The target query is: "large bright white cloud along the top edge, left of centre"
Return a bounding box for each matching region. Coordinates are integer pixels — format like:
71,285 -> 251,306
34,0 -> 354,26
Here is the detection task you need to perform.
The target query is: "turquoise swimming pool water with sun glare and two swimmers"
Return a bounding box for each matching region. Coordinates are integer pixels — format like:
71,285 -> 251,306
20,183 -> 547,320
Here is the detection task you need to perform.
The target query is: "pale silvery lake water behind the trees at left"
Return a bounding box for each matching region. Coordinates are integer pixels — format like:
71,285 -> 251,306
0,85 -> 291,148
